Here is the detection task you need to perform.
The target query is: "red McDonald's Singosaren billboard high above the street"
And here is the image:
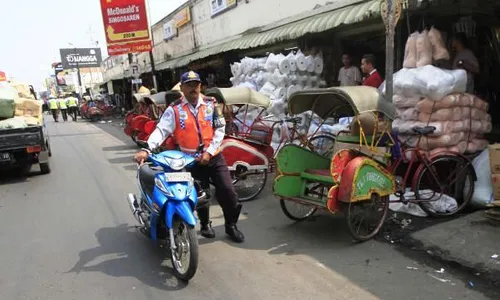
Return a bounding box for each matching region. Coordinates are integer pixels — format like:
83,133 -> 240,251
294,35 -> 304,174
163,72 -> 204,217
101,0 -> 152,55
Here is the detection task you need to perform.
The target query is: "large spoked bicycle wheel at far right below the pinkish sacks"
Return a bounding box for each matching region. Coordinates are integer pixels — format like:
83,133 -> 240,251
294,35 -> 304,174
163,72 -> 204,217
415,155 -> 475,217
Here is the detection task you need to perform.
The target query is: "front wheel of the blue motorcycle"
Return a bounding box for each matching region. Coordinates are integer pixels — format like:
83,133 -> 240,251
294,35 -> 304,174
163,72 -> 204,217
170,219 -> 199,281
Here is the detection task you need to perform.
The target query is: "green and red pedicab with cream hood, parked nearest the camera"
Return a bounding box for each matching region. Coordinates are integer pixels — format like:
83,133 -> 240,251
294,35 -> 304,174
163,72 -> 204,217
273,86 -> 396,241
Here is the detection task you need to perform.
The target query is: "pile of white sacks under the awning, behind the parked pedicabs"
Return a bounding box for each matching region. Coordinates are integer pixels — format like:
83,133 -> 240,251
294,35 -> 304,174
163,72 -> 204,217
230,50 -> 326,152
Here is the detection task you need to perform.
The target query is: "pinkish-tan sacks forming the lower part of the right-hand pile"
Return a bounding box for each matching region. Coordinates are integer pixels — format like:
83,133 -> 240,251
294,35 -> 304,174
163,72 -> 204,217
392,93 -> 492,154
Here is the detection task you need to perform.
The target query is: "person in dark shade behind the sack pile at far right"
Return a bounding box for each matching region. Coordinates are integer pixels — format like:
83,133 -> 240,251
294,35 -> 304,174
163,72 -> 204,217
451,32 -> 479,94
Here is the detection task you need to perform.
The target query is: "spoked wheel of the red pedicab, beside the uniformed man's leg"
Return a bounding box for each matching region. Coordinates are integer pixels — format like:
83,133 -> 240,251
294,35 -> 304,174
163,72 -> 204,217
231,168 -> 268,202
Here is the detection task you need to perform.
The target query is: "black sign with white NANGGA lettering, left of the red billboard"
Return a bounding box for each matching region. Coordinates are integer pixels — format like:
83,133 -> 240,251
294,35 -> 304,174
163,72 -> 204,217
59,48 -> 102,69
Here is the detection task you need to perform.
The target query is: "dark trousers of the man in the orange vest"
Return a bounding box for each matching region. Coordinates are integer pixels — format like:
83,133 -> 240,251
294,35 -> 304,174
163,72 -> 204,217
191,154 -> 241,225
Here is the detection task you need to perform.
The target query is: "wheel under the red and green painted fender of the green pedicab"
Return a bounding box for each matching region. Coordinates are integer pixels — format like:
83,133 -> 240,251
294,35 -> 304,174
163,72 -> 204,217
344,193 -> 389,242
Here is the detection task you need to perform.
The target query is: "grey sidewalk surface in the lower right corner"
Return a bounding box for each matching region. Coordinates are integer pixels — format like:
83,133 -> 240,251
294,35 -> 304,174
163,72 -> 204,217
408,211 -> 500,286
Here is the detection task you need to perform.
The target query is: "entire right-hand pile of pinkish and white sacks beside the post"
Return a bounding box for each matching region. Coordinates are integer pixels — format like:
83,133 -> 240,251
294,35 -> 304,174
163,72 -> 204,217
388,28 -> 491,154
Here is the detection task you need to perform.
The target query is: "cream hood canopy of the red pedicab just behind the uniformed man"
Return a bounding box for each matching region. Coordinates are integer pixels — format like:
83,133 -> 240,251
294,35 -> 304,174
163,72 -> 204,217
205,87 -> 271,108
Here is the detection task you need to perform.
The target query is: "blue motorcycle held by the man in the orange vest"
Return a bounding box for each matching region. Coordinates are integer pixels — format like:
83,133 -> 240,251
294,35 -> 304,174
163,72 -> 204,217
128,151 -> 208,281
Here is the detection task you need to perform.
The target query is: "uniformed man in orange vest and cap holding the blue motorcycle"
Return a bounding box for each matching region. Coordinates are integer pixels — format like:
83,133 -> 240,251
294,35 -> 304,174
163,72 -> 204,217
135,71 -> 245,243
